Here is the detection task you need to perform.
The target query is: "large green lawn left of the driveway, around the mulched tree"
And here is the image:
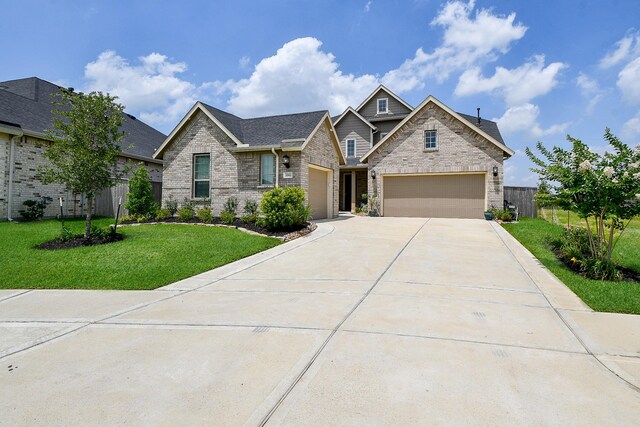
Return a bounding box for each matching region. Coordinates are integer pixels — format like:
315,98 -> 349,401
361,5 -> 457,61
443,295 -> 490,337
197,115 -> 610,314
0,218 -> 280,289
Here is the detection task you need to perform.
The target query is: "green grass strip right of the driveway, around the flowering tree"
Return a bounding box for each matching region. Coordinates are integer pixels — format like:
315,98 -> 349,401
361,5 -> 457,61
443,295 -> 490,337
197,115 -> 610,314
503,218 -> 640,314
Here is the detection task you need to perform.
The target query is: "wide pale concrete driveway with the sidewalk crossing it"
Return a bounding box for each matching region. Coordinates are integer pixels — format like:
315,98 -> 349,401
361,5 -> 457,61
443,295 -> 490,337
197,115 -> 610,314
0,217 -> 640,426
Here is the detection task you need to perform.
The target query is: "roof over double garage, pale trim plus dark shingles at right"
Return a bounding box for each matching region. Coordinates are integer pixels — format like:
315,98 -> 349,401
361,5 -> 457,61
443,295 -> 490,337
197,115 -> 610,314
360,95 -> 514,162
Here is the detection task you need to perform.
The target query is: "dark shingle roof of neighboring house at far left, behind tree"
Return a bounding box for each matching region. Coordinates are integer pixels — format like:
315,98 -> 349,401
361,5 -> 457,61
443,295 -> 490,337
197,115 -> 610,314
0,77 -> 166,159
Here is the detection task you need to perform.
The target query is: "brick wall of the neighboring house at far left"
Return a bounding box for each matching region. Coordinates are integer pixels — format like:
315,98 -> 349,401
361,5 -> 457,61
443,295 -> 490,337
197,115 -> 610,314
0,134 -> 162,220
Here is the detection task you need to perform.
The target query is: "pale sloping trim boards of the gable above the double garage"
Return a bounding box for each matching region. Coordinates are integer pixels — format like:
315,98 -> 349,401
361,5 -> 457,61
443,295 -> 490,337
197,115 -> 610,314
360,95 -> 514,162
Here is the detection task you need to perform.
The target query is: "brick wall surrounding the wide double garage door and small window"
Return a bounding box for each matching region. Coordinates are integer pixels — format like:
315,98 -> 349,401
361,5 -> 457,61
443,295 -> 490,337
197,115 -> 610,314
368,103 -> 504,214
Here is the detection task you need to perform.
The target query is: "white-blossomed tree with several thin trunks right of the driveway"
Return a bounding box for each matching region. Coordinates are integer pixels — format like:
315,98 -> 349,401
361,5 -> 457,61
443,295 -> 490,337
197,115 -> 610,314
526,128 -> 640,263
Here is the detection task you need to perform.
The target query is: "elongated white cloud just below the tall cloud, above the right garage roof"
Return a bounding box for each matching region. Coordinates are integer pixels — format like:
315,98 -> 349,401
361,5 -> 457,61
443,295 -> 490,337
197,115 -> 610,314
455,55 -> 567,106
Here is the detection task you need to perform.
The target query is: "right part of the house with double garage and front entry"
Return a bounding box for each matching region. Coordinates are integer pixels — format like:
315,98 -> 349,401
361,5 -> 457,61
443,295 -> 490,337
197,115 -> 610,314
334,85 -> 514,218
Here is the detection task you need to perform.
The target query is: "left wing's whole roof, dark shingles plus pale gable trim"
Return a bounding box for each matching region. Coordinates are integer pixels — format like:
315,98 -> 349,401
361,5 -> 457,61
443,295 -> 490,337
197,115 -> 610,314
153,101 -> 344,164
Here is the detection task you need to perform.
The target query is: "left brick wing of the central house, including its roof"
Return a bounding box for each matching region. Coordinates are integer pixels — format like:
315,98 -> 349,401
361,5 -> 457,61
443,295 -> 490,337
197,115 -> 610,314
154,102 -> 345,219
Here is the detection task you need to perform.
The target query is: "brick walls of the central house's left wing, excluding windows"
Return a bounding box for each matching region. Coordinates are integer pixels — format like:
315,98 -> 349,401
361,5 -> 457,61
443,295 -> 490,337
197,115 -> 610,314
162,111 -> 338,215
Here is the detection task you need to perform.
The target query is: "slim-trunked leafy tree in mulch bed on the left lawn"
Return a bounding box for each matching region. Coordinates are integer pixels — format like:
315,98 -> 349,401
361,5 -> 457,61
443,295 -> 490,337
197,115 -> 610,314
40,89 -> 124,239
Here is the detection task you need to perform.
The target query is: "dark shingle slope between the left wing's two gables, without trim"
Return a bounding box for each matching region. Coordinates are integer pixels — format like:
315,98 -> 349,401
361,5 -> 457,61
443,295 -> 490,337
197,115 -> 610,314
202,104 -> 327,147
